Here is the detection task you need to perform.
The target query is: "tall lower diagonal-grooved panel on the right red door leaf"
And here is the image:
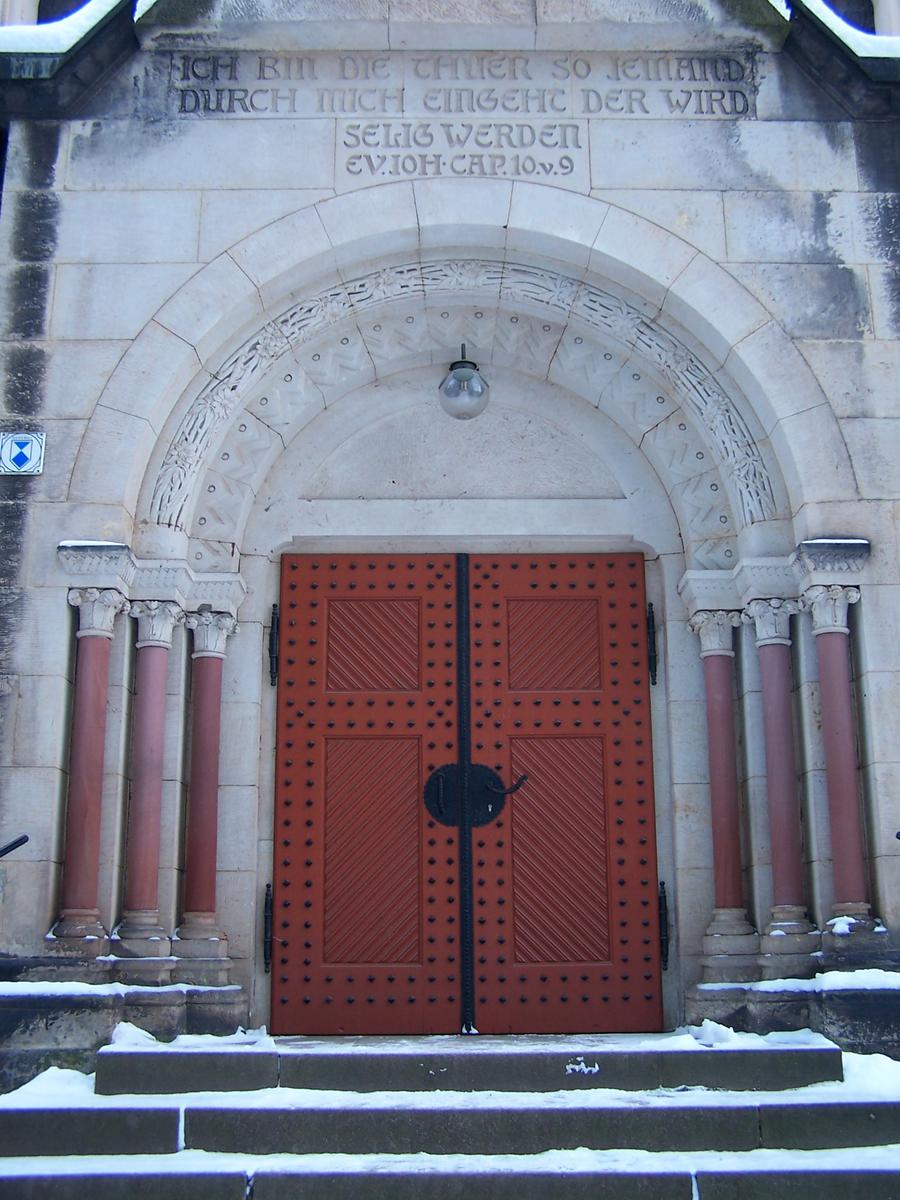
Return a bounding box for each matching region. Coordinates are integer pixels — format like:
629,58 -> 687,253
510,737 -> 610,962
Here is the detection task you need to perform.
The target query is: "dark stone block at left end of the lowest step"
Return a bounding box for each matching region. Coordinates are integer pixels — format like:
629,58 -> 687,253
2,1171 -> 247,1200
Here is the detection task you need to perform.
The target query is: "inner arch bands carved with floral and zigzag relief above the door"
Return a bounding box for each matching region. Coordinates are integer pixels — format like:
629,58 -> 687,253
132,257 -> 784,569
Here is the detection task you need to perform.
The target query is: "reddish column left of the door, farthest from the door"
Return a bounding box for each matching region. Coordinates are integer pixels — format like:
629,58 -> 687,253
53,588 -> 128,958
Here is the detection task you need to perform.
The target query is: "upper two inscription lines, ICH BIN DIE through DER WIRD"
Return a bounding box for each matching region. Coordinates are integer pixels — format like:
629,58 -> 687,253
170,50 -> 756,119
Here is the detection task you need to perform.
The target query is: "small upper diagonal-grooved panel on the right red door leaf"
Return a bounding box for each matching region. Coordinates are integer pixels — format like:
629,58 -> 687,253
508,600 -> 600,691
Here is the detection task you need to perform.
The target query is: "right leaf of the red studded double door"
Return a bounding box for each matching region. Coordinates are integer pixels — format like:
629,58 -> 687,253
470,554 -> 662,1033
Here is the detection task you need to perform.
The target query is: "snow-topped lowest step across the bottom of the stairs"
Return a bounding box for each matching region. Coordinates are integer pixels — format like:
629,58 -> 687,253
4,1145 -> 900,1200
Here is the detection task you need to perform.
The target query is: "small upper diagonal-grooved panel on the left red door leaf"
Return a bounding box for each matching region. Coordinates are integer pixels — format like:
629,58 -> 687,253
326,600 -> 419,691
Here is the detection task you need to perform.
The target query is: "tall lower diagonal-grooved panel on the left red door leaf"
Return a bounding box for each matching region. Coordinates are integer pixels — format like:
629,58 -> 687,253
324,738 -> 420,964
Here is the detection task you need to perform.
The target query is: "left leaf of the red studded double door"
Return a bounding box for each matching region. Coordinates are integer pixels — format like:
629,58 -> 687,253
272,554 -> 460,1033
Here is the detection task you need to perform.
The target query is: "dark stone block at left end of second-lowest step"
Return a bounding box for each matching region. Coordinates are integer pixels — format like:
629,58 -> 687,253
0,1108 -> 179,1157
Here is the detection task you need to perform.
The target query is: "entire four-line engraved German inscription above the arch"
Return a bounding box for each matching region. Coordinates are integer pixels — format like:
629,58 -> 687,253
169,50 -> 756,191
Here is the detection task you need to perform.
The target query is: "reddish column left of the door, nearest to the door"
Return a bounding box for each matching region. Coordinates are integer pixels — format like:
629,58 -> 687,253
173,612 -> 238,983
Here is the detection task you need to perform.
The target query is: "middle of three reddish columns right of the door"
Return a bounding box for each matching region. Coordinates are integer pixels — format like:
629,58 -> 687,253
744,599 -> 821,978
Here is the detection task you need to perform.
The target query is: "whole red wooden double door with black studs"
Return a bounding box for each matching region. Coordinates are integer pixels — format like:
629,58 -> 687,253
272,554 -> 661,1034
